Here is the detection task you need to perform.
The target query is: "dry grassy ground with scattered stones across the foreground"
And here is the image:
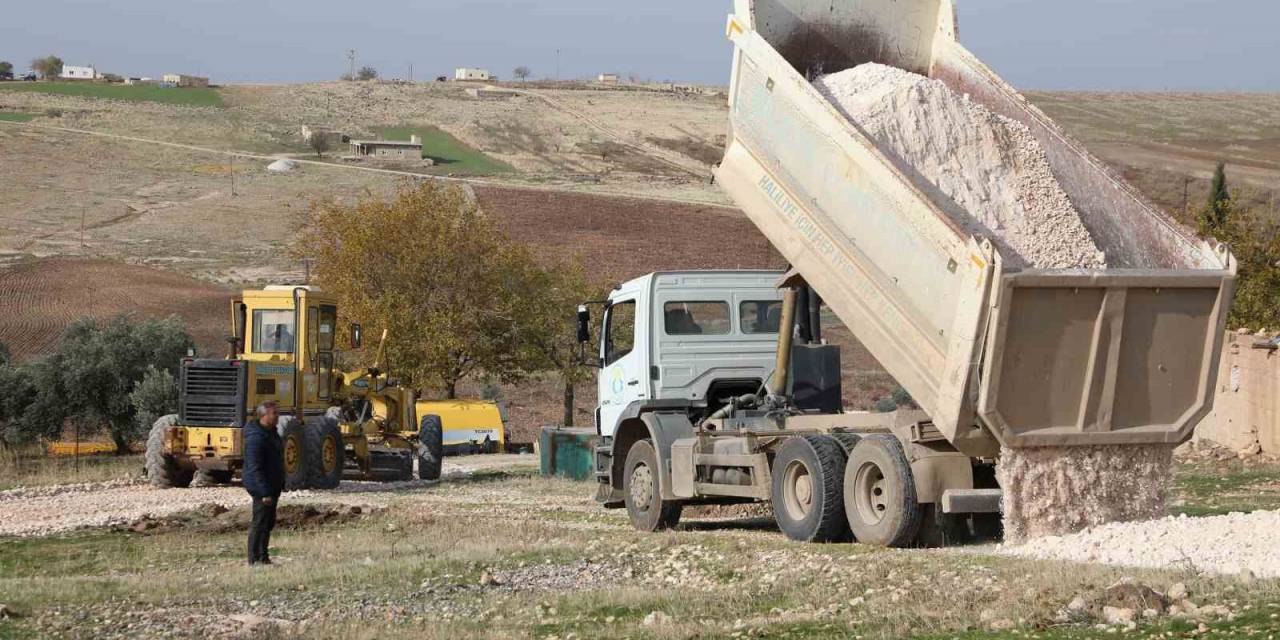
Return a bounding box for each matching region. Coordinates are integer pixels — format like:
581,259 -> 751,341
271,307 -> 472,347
0,461 -> 1280,639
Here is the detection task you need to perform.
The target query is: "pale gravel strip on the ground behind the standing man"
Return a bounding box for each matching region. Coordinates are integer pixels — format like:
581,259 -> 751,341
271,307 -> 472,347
0,454 -> 536,536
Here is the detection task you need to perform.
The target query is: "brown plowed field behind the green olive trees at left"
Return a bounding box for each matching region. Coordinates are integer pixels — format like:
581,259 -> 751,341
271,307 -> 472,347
0,259 -> 230,358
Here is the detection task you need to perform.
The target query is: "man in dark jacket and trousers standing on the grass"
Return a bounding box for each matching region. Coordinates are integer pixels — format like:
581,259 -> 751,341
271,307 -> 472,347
241,401 -> 284,564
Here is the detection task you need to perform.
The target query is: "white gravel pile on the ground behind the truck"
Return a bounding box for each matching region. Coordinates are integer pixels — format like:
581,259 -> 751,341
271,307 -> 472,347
996,511 -> 1280,577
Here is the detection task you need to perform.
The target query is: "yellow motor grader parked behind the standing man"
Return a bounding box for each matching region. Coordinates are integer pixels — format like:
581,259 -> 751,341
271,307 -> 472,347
146,285 -> 443,490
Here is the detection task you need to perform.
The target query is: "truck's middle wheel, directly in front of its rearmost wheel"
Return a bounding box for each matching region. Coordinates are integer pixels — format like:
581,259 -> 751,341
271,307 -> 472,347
771,435 -> 850,543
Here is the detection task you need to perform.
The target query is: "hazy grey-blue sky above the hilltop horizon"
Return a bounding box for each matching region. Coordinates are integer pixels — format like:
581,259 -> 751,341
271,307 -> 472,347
0,0 -> 1280,91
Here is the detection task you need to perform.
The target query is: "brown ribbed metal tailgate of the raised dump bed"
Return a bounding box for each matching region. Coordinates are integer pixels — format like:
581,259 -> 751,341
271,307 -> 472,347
978,267 -> 1235,447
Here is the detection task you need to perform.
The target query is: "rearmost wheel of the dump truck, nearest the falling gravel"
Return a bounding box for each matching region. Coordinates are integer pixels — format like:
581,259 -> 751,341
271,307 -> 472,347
845,434 -> 920,547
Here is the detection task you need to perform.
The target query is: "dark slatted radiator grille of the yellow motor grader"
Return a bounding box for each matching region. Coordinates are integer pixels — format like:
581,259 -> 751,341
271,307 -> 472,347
179,360 -> 244,426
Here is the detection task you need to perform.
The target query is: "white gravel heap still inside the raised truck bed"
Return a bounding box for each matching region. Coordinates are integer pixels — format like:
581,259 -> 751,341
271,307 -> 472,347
814,63 -> 1106,269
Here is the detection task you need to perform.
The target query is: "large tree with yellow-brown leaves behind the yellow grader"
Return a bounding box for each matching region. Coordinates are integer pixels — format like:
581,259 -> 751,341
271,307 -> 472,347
293,180 -> 585,409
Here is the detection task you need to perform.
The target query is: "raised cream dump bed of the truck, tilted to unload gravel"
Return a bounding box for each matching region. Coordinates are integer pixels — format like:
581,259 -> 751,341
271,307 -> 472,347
717,0 -> 1235,457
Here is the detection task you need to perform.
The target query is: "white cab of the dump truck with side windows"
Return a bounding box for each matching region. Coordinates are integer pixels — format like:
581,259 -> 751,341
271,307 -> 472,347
595,271 -> 782,438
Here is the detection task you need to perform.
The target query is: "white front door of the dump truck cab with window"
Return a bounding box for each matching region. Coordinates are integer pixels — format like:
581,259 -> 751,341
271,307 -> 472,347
596,296 -> 649,435
